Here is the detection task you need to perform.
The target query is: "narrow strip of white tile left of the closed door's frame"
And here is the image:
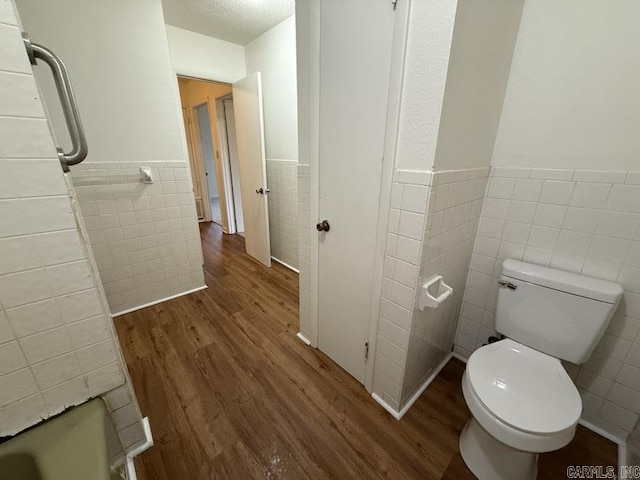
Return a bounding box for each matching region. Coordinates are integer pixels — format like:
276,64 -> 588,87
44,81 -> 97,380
298,165 -> 317,341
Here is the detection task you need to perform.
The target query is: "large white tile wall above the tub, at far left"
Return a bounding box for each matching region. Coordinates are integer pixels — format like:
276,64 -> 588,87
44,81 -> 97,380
0,0 -> 144,456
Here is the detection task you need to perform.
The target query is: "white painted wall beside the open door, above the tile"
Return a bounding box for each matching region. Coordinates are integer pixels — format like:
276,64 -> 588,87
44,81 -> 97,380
245,15 -> 298,161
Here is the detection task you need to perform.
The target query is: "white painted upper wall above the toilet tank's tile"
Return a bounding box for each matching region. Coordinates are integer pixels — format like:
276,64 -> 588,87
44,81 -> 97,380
492,0 -> 640,170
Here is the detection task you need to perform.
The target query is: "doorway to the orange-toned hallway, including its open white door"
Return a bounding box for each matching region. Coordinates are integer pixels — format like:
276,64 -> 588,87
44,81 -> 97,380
178,77 -> 271,266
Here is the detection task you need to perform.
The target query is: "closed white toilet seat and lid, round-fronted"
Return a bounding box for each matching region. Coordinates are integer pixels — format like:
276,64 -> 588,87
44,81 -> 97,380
463,339 -> 582,452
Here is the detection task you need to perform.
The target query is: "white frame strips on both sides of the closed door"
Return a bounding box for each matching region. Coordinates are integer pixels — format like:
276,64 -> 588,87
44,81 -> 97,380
296,0 -> 412,392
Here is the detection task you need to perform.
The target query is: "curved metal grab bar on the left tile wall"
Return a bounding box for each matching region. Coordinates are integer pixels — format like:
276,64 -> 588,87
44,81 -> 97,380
22,32 -> 88,172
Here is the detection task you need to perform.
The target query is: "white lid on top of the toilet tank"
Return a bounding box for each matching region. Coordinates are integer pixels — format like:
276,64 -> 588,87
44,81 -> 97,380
502,259 -> 623,304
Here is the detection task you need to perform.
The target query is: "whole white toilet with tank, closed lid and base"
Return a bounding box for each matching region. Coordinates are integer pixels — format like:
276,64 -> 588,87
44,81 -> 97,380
460,260 -> 622,480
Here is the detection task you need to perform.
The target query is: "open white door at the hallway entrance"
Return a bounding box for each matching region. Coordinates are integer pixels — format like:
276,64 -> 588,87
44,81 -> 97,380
233,72 -> 271,267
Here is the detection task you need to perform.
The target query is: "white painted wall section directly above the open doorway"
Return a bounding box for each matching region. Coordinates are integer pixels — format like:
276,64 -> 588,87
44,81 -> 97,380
166,25 -> 246,83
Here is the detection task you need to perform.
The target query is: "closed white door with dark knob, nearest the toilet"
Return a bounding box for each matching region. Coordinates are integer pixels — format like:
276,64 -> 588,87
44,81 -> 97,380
318,0 -> 393,383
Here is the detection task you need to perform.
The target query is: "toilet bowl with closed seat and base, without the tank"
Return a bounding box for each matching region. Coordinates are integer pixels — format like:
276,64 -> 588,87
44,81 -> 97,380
460,339 -> 582,480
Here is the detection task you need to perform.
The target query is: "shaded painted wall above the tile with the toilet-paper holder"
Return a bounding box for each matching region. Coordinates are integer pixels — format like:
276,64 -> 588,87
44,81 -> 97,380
433,0 -> 524,170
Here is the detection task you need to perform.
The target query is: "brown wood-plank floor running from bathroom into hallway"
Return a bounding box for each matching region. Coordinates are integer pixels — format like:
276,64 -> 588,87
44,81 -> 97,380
116,224 -> 617,480
